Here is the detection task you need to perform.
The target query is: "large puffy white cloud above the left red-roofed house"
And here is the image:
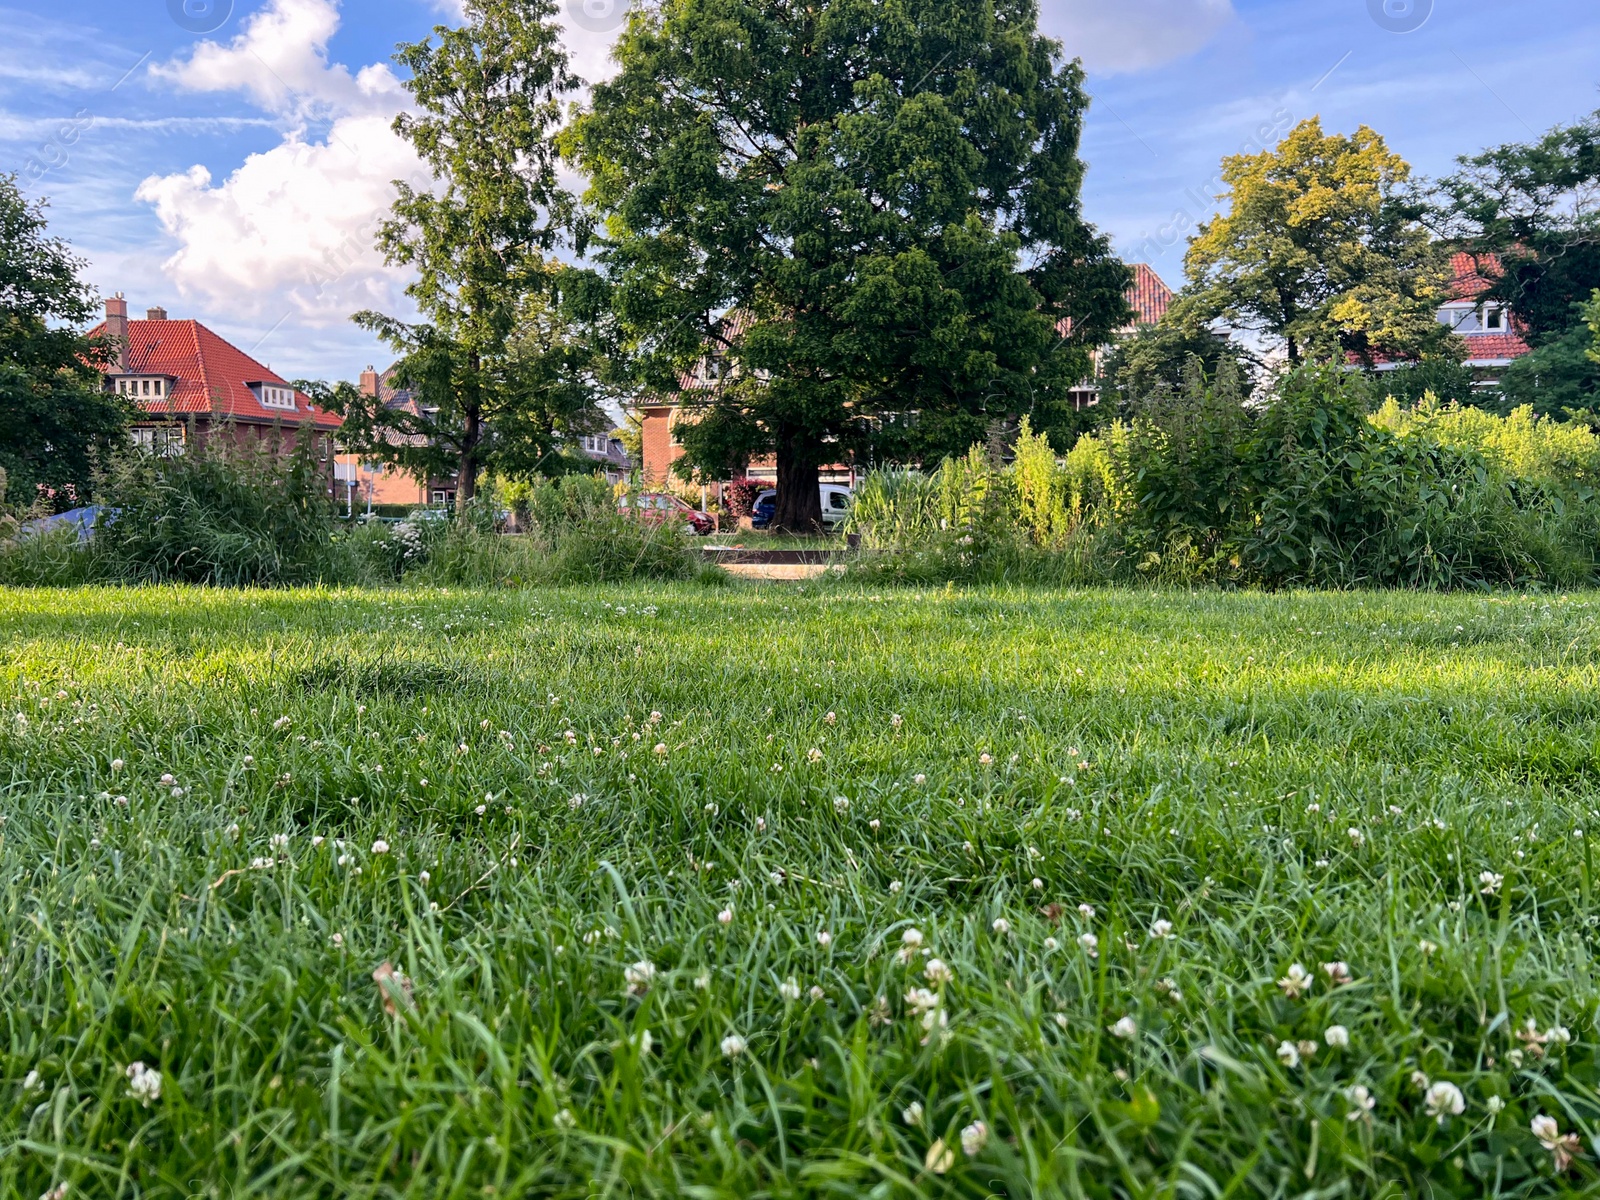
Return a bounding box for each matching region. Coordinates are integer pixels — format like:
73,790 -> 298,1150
136,115 -> 424,326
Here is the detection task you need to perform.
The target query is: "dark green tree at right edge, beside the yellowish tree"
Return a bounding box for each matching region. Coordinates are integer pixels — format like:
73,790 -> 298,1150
1434,112 -> 1600,346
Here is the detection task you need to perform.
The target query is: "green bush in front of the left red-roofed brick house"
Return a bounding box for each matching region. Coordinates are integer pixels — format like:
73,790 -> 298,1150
91,426 -> 346,587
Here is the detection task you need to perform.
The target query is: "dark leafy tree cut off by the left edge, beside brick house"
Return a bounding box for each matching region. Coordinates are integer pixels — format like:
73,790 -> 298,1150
0,176 -> 130,507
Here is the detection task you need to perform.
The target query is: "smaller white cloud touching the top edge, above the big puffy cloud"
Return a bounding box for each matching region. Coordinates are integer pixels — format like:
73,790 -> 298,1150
150,0 -> 406,117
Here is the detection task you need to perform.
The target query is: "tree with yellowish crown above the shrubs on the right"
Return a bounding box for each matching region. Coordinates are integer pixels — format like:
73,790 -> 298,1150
1184,118 -> 1459,366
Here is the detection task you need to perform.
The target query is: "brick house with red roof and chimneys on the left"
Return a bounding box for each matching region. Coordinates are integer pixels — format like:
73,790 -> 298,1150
93,294 -> 342,473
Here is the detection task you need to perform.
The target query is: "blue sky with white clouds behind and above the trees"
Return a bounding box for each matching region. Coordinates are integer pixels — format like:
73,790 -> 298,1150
0,0 -> 1600,378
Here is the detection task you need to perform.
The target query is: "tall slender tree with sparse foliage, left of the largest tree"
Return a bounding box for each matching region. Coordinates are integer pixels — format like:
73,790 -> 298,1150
347,0 -> 579,507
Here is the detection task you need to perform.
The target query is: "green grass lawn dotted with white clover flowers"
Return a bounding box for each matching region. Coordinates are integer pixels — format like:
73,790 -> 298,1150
0,586 -> 1600,1200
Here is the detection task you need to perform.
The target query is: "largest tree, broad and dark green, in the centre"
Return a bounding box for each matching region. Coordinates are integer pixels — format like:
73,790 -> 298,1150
568,0 -> 1128,528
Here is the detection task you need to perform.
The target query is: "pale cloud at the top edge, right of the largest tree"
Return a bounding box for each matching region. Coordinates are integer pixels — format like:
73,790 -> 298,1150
1040,0 -> 1234,74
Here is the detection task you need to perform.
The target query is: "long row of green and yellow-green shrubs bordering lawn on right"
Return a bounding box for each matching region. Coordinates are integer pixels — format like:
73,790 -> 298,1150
853,362 -> 1600,589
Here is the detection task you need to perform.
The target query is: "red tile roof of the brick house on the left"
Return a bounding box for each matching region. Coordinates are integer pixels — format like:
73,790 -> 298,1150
93,320 -> 342,429
